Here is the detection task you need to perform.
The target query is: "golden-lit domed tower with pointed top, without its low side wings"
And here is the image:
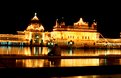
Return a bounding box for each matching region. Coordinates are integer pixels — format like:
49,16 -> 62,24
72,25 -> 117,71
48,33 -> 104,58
19,13 -> 47,45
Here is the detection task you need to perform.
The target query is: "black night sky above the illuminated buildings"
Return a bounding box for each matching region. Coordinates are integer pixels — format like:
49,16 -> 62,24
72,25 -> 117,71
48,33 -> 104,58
0,0 -> 121,38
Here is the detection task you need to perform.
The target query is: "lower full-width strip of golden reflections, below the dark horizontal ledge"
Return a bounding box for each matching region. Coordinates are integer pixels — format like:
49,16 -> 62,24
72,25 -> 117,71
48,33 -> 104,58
4,58 -> 121,68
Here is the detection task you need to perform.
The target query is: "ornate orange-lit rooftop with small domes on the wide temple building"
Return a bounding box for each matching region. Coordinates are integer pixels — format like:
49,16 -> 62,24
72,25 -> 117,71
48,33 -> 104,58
53,18 -> 97,31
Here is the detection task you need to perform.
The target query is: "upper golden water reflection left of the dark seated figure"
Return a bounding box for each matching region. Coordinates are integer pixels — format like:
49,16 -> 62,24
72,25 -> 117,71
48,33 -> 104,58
0,46 -> 48,56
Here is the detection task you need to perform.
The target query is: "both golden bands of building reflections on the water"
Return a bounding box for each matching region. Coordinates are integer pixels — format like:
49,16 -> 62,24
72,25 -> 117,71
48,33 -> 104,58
0,46 -> 121,67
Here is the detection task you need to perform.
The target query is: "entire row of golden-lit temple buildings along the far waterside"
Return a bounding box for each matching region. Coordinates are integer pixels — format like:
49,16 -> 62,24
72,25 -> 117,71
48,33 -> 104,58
0,13 -> 121,48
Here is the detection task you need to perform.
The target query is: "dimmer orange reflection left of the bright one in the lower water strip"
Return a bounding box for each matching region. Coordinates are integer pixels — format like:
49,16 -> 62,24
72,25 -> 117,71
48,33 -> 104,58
16,59 -> 61,68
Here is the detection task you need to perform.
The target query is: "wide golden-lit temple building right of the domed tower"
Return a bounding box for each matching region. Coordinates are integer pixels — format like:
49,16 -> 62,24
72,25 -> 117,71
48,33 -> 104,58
51,18 -> 99,47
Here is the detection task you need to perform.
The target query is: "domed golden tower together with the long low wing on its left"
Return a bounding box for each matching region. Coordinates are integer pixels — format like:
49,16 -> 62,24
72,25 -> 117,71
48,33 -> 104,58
0,13 -> 50,45
